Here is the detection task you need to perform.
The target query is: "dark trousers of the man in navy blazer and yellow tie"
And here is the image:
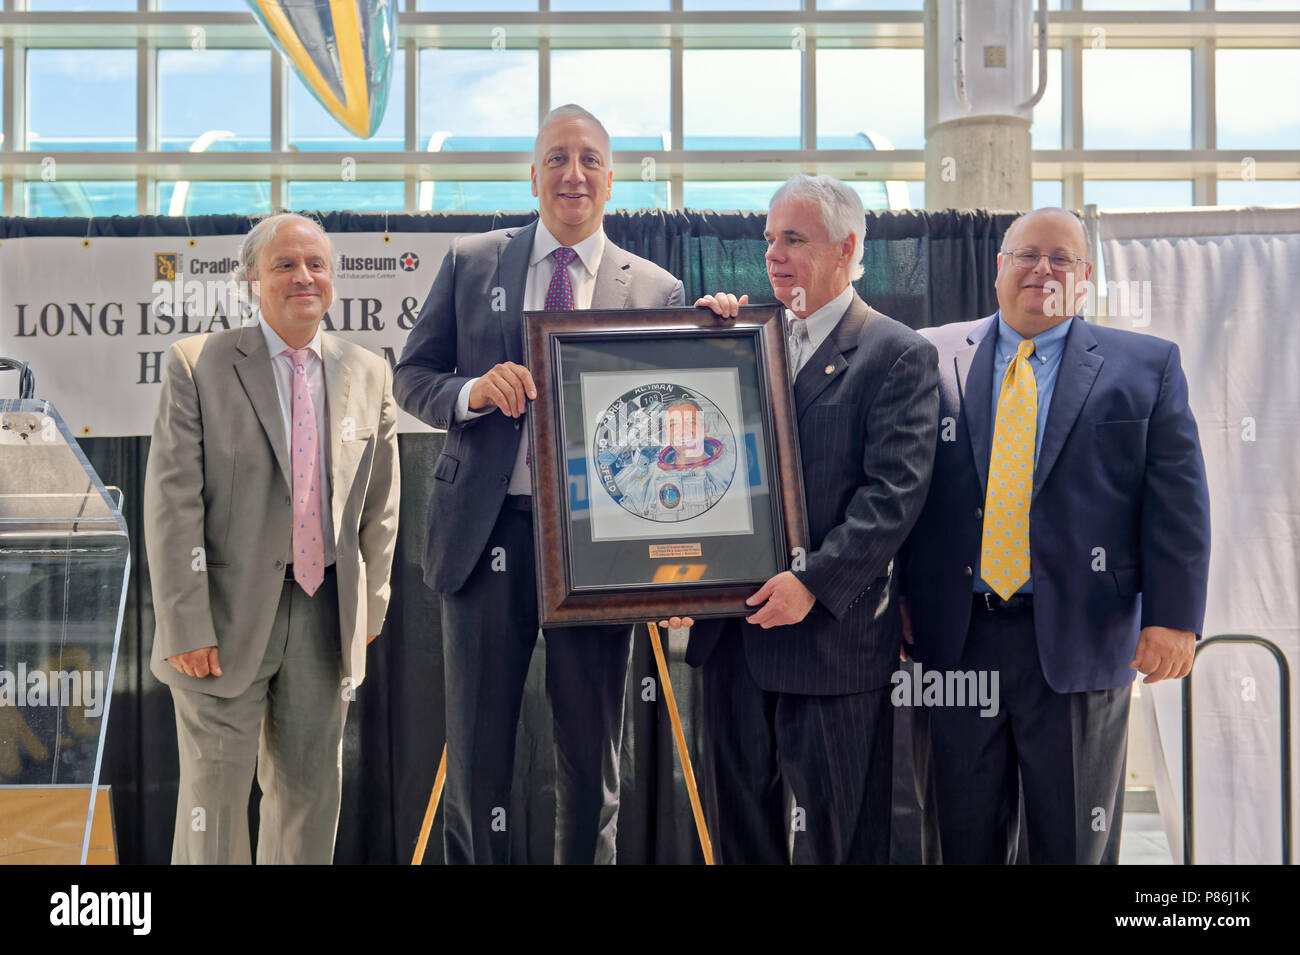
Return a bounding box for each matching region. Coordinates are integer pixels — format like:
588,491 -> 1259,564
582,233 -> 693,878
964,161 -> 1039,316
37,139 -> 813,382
913,599 -> 1131,865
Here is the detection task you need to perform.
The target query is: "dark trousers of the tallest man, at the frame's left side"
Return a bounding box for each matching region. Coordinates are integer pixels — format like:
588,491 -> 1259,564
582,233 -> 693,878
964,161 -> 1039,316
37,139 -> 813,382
442,503 -> 632,864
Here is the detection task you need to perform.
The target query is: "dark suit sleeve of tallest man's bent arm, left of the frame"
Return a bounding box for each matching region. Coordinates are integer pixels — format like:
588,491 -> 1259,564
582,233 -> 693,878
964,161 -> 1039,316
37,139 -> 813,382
393,240 -> 488,429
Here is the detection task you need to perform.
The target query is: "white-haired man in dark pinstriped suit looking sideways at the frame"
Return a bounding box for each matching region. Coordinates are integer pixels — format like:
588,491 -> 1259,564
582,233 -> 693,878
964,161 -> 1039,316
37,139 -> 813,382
668,175 -> 939,863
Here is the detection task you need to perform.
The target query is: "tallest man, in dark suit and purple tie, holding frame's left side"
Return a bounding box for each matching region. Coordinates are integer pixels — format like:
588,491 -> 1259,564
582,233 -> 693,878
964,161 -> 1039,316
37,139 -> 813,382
393,105 -> 685,863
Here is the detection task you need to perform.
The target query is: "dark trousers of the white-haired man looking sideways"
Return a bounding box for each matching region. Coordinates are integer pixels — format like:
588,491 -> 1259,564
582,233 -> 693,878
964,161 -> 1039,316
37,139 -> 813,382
703,626 -> 893,864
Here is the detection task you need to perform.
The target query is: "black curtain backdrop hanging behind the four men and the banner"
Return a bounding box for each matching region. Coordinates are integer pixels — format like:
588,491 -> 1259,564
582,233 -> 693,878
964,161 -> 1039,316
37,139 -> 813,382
0,210 -> 1014,864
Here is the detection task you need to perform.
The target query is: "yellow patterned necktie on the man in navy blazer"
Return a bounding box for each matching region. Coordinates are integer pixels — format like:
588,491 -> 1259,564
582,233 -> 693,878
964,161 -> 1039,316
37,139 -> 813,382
979,340 -> 1039,600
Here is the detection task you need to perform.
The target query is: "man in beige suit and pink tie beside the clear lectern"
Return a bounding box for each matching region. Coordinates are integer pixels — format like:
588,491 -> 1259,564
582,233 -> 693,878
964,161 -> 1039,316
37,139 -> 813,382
144,213 -> 399,864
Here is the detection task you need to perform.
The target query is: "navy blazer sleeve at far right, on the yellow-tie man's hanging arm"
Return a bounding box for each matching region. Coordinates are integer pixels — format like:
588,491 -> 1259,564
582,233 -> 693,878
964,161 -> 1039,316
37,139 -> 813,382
1140,344 -> 1210,634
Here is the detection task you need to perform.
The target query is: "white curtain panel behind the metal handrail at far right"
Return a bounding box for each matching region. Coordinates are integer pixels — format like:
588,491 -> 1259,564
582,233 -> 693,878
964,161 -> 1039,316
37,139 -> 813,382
1099,208 -> 1300,864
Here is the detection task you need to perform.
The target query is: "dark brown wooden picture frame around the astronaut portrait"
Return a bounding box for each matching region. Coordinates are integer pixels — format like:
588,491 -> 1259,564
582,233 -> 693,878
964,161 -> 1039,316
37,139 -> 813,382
524,305 -> 809,626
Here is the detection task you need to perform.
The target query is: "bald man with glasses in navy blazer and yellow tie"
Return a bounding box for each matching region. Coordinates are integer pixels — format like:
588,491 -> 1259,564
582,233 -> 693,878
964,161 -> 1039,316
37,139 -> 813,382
894,209 -> 1210,864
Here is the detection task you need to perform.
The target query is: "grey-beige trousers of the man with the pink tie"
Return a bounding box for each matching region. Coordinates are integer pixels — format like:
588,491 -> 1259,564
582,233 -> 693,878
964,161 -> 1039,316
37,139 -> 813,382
172,568 -> 347,865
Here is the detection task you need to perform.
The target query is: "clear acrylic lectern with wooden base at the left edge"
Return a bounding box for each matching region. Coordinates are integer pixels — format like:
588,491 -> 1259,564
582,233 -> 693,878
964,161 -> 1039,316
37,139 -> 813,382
0,399 -> 130,863
